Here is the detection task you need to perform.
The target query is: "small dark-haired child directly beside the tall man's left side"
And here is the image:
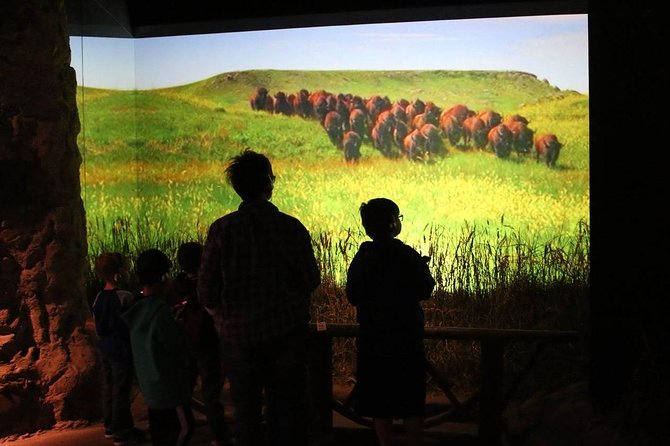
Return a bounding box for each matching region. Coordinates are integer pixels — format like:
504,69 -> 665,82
168,242 -> 232,446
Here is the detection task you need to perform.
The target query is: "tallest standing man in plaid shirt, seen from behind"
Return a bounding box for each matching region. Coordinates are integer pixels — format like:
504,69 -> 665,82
198,149 -> 320,446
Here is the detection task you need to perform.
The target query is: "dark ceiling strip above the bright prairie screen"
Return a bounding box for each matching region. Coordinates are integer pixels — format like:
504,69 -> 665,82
65,0 -> 587,38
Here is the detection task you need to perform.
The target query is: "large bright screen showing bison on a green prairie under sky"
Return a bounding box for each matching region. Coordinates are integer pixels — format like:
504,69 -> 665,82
71,14 -> 590,282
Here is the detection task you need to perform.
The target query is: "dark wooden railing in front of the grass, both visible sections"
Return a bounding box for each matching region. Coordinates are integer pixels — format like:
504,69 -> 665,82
310,323 -> 580,445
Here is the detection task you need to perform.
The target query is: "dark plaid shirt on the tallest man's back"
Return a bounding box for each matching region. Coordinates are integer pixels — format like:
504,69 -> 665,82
198,200 -> 321,343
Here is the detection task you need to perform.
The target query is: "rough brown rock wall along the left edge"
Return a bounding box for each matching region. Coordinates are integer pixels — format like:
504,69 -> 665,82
0,0 -> 100,437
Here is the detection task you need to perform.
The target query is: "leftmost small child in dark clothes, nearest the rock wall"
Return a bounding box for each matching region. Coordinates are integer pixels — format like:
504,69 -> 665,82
92,252 -> 146,446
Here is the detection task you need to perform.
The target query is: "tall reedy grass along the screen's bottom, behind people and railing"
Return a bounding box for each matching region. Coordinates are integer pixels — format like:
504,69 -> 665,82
88,218 -> 590,391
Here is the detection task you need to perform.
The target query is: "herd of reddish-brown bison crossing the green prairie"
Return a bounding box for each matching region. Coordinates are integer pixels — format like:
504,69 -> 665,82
249,87 -> 563,167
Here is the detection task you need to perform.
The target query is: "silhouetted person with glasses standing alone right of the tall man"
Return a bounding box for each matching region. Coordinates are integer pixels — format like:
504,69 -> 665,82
346,198 -> 435,446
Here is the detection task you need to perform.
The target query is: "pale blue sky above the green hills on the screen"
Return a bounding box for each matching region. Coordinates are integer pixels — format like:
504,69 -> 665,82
70,14 -> 589,94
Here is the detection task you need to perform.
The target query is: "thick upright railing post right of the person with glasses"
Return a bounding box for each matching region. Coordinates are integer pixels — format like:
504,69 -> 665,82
479,338 -> 505,446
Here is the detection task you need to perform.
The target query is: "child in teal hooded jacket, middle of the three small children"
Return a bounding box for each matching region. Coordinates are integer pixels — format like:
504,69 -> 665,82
123,249 -> 195,446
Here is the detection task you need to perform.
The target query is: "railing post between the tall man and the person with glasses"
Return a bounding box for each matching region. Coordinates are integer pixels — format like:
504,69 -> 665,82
309,331 -> 333,437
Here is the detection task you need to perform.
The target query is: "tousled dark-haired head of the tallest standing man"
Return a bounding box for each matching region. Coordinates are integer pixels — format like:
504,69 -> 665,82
226,149 -> 275,201
